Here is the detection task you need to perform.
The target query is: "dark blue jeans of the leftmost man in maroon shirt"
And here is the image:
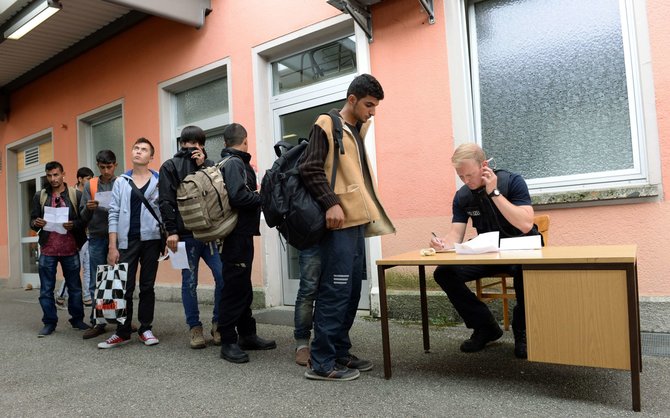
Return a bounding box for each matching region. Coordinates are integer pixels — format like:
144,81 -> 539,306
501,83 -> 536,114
39,254 -> 84,325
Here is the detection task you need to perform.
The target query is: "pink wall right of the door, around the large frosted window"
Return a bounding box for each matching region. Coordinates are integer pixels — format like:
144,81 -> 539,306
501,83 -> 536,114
370,0 -> 670,296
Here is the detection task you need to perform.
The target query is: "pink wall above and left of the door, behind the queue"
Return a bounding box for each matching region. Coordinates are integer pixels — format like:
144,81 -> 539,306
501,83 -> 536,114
0,0 -> 339,283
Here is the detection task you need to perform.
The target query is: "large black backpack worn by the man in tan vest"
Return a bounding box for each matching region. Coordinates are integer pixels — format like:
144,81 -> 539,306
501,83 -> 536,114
260,109 -> 344,250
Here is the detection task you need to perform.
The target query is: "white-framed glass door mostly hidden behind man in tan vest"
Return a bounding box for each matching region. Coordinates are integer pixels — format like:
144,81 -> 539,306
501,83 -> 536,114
274,93 -> 370,309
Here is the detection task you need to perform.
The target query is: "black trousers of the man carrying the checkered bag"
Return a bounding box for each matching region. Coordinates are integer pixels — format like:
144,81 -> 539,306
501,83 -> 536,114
116,239 -> 162,339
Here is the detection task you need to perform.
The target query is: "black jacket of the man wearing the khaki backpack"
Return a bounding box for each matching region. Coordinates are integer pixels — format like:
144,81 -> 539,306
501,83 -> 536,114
158,148 -> 214,237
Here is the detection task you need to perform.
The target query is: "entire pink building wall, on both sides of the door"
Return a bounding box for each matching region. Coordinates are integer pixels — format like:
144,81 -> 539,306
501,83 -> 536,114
0,0 -> 670,296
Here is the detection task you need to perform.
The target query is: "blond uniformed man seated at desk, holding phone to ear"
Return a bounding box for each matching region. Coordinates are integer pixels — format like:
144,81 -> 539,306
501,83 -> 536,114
430,143 -> 539,358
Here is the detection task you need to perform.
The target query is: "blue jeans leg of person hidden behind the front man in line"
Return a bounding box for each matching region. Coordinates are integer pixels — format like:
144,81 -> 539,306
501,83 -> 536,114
293,245 -> 321,346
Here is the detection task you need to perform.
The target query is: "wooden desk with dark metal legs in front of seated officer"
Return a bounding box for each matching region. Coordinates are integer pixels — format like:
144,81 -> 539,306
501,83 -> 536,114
377,245 -> 642,411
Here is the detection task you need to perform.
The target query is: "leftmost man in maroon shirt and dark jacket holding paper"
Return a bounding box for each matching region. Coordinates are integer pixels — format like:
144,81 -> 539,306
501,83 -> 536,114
30,161 -> 89,337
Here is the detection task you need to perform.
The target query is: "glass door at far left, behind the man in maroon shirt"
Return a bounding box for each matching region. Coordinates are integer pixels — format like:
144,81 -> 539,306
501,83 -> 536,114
18,171 -> 46,288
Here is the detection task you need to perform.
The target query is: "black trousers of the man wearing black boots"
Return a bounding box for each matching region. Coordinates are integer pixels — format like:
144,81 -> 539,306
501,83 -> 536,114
219,234 -> 256,344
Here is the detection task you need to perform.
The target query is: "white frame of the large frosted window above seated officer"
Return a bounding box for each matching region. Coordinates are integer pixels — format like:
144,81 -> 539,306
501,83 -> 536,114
445,0 -> 661,195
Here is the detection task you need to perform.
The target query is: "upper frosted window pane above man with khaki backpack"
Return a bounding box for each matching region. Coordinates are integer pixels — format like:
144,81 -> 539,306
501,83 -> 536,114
176,77 -> 228,125
